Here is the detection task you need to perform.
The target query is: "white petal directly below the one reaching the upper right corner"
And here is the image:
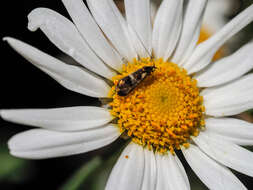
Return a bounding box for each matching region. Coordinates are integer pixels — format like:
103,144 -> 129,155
197,42 -> 253,87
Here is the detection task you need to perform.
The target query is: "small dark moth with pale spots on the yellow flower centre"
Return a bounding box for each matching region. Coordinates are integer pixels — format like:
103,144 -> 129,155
116,66 -> 156,96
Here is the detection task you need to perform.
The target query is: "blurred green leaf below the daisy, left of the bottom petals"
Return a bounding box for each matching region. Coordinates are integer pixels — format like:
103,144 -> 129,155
61,157 -> 102,190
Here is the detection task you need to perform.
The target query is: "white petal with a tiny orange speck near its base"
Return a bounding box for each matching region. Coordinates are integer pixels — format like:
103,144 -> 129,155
105,143 -> 144,190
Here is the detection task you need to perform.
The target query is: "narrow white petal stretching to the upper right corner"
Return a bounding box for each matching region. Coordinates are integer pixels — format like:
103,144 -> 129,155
184,5 -> 253,74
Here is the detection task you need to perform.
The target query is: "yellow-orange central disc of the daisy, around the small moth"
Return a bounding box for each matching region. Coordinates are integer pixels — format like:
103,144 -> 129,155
109,58 -> 205,154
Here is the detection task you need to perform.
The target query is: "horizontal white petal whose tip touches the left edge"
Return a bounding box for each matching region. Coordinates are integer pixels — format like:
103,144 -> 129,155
0,106 -> 112,131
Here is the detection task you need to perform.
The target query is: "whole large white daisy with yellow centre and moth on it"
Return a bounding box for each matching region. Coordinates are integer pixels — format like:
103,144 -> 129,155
1,0 -> 253,190
